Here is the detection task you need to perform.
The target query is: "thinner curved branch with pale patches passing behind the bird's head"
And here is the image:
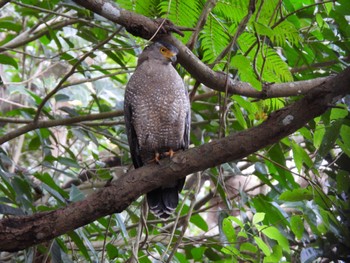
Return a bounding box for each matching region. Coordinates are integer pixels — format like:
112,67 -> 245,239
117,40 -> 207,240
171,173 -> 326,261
69,0 -> 332,99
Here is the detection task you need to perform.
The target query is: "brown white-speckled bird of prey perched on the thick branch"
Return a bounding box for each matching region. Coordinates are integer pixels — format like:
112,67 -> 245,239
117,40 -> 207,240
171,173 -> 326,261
124,41 -> 190,218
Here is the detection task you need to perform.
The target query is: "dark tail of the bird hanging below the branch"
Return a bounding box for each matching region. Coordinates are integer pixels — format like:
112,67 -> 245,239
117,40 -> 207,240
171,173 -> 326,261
147,180 -> 184,219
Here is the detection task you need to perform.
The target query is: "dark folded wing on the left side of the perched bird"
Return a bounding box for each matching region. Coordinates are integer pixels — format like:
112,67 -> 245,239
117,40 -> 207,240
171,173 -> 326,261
124,103 -> 143,168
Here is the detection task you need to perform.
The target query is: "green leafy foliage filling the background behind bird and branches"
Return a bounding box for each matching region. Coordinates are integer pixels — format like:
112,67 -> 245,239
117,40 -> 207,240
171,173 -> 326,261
0,0 -> 350,263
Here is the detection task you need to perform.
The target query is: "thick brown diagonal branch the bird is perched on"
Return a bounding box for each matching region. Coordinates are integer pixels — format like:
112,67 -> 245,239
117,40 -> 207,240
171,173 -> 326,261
0,68 -> 350,251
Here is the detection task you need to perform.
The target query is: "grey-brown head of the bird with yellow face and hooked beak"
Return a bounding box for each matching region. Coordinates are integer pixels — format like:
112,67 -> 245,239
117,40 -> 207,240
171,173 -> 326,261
138,41 -> 179,65
